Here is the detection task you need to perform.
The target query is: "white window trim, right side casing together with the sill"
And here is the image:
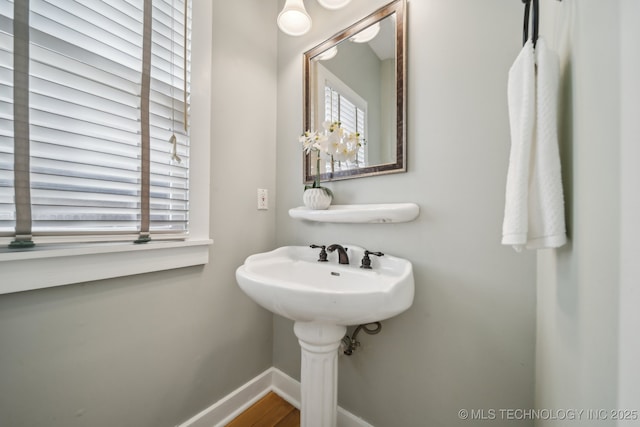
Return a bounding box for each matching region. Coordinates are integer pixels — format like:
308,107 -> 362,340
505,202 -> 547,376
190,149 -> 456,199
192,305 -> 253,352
0,1 -> 213,294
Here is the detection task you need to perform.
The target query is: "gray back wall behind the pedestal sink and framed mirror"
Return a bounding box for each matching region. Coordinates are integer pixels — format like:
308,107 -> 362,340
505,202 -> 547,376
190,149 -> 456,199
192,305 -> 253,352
274,0 -> 535,427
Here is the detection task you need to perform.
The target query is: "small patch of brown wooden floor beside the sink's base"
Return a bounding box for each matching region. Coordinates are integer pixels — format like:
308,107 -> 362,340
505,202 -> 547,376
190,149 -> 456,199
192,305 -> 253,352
227,391 -> 300,427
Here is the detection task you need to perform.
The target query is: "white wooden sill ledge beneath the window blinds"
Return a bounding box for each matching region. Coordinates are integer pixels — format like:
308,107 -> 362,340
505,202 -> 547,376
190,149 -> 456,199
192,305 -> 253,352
0,239 -> 213,294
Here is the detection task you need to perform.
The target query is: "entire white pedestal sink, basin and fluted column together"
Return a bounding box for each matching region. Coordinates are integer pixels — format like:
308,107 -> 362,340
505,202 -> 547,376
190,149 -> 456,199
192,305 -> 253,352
236,244 -> 414,427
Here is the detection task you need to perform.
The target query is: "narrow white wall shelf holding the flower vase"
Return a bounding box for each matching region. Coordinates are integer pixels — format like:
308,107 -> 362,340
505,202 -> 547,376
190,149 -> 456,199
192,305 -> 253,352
289,203 -> 420,224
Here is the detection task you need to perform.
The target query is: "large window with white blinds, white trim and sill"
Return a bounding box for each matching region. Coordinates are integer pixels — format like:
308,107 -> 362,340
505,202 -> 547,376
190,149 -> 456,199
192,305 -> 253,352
0,0 -> 212,294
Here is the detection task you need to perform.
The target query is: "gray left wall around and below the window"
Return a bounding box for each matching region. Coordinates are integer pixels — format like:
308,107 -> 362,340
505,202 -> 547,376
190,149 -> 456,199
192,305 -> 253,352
0,0 -> 277,427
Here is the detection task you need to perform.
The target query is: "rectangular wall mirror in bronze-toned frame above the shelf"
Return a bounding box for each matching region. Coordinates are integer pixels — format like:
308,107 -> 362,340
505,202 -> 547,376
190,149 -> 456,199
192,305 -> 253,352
304,0 -> 406,183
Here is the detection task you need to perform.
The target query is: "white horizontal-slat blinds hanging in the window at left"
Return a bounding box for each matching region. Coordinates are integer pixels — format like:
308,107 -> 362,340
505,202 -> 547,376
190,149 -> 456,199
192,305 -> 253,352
0,0 -> 191,247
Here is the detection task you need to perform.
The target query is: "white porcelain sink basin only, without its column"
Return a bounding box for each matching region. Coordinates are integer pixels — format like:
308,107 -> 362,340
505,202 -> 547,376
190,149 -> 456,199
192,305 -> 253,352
236,244 -> 414,326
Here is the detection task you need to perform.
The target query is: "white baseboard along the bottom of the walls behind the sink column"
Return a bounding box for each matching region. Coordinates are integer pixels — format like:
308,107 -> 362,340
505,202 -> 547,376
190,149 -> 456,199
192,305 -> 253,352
177,367 -> 373,427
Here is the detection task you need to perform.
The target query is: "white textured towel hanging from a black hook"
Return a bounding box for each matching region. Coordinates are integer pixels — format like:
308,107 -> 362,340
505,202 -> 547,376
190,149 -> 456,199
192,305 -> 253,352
502,38 -> 567,251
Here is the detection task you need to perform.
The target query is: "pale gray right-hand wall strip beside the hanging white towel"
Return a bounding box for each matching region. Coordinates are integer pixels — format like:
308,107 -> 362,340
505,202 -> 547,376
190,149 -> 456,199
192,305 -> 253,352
536,0 -> 620,426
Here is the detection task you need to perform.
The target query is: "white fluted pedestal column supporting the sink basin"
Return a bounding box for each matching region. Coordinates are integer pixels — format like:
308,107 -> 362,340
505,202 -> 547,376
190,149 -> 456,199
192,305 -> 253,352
293,322 -> 347,427
